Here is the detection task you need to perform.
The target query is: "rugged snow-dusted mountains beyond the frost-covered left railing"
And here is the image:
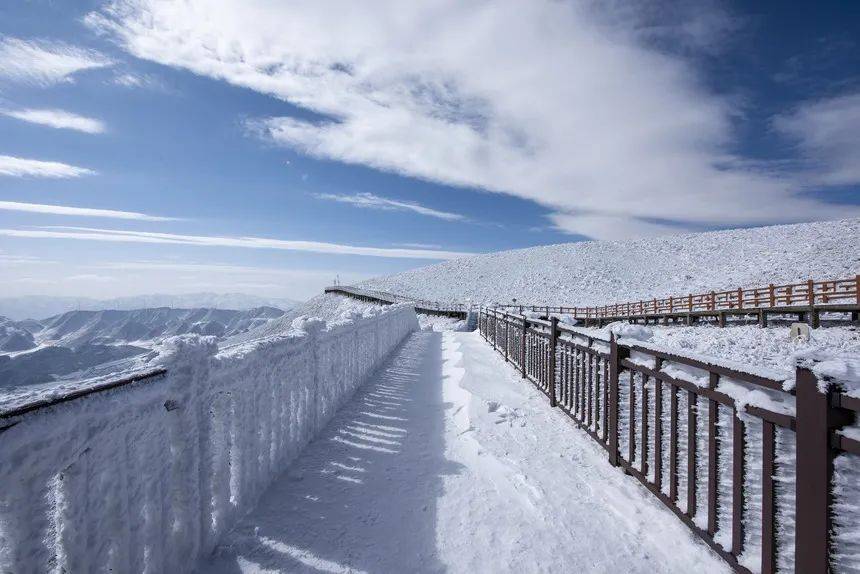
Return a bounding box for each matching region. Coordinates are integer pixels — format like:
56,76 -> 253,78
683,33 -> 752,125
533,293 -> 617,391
0,306 -> 284,388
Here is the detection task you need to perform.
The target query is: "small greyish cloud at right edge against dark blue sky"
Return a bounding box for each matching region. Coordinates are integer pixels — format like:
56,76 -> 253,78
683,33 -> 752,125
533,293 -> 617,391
774,93 -> 860,185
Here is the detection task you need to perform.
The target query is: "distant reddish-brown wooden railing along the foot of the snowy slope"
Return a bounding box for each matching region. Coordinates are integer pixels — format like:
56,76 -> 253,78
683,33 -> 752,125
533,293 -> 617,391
494,275 -> 860,320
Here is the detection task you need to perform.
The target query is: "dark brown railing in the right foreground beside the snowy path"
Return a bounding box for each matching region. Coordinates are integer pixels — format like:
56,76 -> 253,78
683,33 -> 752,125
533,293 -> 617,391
478,309 -> 860,574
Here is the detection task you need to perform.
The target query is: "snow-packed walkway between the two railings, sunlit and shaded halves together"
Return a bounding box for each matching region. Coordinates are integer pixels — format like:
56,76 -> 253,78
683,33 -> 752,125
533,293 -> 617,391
199,332 -> 729,574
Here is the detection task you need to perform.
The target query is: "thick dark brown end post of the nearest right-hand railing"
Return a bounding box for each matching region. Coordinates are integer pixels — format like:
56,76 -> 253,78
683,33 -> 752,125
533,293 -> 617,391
794,367 -> 850,572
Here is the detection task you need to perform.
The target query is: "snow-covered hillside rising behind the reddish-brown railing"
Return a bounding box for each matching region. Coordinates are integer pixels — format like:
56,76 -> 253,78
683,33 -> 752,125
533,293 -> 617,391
360,218 -> 860,305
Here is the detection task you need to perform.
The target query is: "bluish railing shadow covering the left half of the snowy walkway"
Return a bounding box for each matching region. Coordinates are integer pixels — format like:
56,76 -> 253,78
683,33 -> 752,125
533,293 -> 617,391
201,332 -> 460,574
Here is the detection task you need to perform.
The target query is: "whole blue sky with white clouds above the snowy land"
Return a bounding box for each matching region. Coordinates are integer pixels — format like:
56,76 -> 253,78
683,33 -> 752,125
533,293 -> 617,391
0,0 -> 860,298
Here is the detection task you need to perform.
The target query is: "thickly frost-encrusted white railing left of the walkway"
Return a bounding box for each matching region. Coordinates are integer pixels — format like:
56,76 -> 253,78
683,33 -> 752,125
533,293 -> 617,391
0,306 -> 418,574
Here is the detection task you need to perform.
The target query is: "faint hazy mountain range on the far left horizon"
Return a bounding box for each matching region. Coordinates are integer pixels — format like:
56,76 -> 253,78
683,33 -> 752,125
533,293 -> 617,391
0,293 -> 299,321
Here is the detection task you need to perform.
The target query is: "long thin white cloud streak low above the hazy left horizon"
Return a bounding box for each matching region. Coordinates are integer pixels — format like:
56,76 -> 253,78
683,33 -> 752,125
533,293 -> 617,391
0,226 -> 472,259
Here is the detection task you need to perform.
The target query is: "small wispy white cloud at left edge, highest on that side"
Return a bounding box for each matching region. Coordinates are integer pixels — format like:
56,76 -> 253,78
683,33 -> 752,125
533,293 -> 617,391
0,36 -> 113,86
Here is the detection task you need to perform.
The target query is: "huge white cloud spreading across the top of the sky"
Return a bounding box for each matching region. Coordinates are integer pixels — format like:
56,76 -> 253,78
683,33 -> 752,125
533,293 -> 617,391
87,0 -> 860,240
